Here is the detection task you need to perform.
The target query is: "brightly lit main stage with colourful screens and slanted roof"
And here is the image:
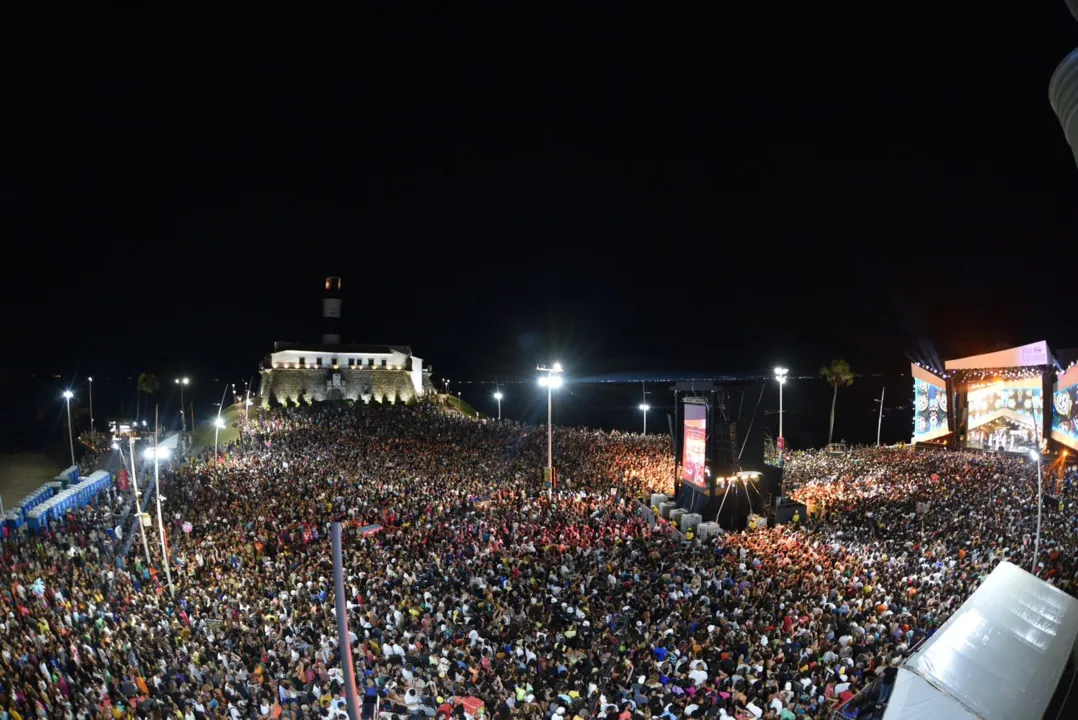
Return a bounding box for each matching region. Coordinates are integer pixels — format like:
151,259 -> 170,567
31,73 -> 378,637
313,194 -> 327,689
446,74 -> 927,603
911,341 -> 1056,454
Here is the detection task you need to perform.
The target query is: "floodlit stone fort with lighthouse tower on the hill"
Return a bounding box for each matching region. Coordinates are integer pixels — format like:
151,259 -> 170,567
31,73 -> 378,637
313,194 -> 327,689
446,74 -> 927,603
259,277 -> 433,405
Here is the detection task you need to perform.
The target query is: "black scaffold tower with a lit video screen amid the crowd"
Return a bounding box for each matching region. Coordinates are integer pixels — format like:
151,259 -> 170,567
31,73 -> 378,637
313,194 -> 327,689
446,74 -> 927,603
671,379 -> 782,529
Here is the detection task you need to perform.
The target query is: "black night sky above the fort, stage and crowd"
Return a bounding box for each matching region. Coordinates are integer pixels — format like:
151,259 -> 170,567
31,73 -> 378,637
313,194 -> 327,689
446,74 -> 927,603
0,0 -> 1078,444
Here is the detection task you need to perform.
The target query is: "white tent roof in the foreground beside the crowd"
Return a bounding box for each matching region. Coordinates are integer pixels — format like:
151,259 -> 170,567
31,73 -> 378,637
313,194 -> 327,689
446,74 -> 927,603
884,563 -> 1078,720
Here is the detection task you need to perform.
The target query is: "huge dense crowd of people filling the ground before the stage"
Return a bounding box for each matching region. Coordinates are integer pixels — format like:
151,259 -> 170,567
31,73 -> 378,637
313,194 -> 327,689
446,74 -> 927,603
0,404 -> 1078,720
